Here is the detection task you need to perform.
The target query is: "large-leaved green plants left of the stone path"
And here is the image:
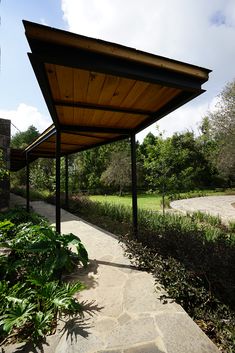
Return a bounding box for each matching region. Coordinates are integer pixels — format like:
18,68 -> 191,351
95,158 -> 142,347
0,208 -> 88,345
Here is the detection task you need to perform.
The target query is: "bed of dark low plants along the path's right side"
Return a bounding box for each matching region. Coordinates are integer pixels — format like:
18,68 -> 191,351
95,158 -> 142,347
62,197 -> 235,353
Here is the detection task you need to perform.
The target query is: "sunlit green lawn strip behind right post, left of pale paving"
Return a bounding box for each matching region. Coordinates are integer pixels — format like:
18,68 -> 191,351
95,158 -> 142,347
89,194 -> 161,210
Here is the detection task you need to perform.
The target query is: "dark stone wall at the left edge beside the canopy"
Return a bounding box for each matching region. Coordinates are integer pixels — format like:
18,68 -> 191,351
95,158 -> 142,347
0,119 -> 11,209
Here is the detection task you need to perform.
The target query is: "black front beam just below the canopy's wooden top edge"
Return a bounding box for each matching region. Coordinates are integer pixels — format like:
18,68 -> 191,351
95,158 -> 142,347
26,44 -> 206,91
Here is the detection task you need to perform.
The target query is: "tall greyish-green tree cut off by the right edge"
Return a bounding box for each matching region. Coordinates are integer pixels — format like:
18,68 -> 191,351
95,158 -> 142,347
207,79 -> 235,186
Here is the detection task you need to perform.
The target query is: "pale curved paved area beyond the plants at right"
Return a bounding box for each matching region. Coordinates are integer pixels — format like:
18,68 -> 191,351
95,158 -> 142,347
171,195 -> 235,223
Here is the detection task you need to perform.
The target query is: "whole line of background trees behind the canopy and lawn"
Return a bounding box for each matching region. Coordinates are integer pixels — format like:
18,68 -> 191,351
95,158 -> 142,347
11,80 -> 235,194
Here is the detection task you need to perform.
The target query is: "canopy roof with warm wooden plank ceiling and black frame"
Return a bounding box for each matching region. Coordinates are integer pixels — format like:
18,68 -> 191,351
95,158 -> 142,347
10,21 -> 210,170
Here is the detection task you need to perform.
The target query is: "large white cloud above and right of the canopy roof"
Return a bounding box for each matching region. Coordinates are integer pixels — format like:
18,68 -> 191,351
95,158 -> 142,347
61,0 -> 235,138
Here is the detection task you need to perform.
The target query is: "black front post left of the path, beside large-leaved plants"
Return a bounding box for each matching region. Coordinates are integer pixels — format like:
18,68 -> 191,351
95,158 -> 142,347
55,130 -> 61,233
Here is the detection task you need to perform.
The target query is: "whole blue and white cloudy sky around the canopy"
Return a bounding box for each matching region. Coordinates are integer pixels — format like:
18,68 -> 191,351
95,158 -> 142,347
0,0 -> 235,141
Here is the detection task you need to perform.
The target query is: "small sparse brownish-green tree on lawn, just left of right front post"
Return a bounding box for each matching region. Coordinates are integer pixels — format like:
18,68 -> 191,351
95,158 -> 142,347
101,151 -> 131,196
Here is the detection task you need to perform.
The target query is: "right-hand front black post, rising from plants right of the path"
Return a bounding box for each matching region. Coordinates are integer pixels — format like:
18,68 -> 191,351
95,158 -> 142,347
131,134 -> 138,238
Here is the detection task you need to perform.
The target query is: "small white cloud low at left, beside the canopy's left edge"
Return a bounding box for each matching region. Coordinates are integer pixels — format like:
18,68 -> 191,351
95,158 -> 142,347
0,103 -> 52,135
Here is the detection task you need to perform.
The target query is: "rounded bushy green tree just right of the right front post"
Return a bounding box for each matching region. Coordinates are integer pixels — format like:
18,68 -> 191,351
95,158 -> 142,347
140,132 -> 220,193
